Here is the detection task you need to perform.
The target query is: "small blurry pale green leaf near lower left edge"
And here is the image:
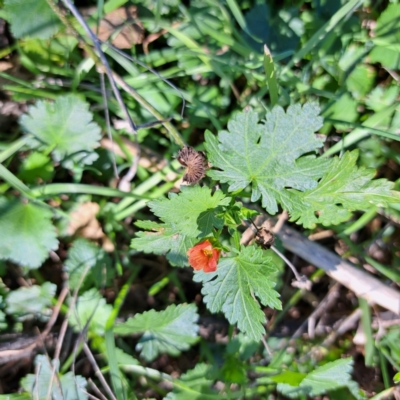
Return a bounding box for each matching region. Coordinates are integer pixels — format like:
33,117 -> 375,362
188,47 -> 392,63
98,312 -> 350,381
6,282 -> 57,321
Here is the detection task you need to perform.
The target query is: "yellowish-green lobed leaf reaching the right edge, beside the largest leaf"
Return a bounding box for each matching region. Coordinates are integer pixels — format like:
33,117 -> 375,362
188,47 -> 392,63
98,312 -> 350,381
288,150 -> 400,228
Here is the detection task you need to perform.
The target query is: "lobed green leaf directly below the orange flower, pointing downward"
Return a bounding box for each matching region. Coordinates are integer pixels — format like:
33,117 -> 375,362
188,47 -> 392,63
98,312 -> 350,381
194,246 -> 282,340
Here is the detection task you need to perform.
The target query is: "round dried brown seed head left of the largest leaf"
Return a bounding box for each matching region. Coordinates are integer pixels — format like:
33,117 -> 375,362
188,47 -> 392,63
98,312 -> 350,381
176,146 -> 209,185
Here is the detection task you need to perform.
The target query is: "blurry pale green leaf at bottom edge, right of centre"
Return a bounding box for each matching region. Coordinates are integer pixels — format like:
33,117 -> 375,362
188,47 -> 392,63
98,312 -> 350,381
272,358 -> 365,399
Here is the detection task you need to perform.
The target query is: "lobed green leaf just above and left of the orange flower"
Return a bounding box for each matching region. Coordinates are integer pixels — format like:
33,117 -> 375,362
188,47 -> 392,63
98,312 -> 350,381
131,186 -> 231,267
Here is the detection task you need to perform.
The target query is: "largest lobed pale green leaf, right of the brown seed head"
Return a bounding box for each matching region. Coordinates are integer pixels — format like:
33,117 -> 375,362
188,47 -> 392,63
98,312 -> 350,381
205,104 -> 329,214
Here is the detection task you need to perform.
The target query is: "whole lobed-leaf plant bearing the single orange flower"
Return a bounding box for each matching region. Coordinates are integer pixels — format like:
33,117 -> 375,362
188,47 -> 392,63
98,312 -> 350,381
132,104 -> 400,340
